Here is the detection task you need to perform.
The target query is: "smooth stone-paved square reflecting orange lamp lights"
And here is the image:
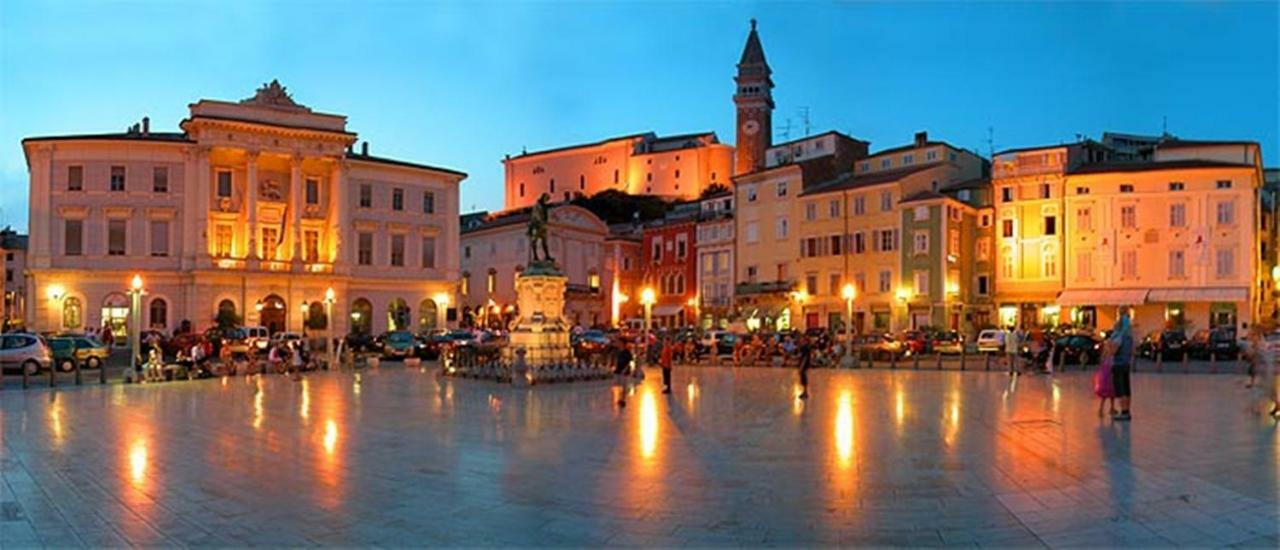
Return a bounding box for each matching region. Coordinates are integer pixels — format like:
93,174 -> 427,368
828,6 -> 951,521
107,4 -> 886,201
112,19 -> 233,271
0,366 -> 1280,547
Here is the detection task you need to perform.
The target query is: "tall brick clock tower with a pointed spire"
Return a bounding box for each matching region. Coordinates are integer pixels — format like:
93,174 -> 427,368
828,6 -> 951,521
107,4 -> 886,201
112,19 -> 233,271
733,19 -> 773,175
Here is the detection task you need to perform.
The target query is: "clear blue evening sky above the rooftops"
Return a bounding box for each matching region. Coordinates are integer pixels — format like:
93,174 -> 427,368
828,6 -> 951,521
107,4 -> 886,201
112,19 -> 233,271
0,0 -> 1280,229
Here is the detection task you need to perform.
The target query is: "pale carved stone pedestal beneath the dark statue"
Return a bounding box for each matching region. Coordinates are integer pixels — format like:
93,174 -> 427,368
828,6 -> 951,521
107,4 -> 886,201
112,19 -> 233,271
503,262 -> 573,366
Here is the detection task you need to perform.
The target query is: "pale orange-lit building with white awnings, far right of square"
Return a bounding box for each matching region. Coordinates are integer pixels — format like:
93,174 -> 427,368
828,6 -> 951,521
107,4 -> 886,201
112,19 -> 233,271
1056,139 -> 1275,335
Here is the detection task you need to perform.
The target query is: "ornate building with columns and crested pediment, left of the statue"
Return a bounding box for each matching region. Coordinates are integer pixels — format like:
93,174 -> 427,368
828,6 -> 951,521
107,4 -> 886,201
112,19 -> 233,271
23,81 -> 466,340
